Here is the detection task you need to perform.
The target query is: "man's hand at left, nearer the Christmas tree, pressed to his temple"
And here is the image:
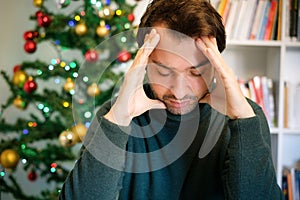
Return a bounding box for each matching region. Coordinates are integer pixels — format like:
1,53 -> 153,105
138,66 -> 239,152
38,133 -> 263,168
104,29 -> 166,126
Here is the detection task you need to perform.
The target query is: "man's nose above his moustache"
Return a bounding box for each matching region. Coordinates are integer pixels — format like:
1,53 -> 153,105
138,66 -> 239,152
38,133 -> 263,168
170,75 -> 188,99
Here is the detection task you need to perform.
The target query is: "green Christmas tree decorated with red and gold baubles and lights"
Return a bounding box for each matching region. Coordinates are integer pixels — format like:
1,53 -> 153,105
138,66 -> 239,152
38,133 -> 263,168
0,0 -> 141,200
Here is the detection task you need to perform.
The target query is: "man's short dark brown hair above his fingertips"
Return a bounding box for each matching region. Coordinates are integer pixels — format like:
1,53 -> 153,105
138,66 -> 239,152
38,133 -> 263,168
137,0 -> 226,52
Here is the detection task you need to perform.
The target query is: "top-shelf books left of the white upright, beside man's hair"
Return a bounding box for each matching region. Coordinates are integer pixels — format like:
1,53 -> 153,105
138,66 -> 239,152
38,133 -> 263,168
212,0 -> 282,40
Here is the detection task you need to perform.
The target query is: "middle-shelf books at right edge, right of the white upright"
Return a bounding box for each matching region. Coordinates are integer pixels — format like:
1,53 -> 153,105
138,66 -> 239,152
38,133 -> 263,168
284,81 -> 300,129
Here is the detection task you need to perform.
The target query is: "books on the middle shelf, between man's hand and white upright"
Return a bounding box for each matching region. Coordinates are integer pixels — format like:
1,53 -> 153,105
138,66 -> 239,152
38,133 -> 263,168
238,76 -> 276,127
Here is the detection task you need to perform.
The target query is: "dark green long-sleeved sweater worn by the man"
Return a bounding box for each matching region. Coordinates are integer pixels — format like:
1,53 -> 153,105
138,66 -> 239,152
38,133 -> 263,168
60,88 -> 283,200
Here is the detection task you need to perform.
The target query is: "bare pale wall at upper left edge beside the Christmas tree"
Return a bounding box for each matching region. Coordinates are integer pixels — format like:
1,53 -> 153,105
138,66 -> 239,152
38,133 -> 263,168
0,0 -> 36,115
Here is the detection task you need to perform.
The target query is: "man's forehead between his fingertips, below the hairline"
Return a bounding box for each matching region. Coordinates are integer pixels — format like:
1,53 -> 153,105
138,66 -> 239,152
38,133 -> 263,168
151,27 -> 206,66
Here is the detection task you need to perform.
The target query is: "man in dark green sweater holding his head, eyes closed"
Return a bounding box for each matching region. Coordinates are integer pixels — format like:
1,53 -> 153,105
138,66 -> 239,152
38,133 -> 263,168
60,0 -> 283,200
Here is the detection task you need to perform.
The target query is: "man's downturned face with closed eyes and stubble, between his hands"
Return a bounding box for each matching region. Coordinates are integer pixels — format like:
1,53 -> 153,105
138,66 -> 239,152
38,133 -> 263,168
147,28 -> 213,115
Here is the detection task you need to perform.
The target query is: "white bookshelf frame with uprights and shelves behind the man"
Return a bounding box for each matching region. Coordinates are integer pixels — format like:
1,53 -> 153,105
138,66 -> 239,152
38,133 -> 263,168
222,0 -> 300,185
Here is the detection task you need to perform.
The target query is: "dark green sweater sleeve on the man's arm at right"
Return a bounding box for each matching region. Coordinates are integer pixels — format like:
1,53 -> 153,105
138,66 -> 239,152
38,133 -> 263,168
223,105 -> 283,200
